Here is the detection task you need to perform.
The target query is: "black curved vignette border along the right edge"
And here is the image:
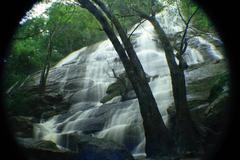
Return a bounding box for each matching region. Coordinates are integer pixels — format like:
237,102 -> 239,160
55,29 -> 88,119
195,0 -> 240,160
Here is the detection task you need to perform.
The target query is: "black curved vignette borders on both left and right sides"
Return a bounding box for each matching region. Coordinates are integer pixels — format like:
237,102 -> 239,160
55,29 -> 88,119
0,0 -> 240,160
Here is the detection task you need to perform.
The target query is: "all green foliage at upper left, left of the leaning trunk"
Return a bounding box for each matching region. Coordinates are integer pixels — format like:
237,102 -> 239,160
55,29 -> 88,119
4,2 -> 104,90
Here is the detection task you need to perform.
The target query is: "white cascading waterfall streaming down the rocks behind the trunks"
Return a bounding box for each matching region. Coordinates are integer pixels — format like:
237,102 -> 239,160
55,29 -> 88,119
32,5 -> 222,158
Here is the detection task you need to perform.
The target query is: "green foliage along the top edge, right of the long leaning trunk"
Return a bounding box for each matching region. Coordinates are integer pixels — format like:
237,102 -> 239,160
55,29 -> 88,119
104,0 -> 214,32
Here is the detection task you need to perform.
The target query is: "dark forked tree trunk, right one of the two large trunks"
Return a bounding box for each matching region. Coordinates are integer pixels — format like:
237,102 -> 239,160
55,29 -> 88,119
148,16 -> 200,152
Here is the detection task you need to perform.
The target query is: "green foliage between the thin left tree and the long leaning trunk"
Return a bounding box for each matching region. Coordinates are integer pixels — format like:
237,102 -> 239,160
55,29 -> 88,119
48,3 -> 104,55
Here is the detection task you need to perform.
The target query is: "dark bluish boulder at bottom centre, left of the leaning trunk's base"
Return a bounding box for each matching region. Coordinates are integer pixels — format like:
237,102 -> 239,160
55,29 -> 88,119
57,134 -> 134,160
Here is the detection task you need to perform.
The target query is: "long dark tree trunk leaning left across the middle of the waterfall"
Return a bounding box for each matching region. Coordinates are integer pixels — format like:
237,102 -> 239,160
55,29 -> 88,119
78,0 -> 173,157
